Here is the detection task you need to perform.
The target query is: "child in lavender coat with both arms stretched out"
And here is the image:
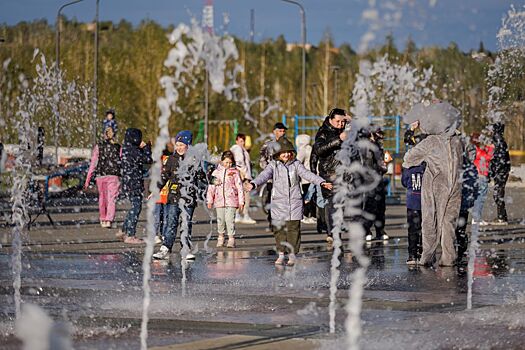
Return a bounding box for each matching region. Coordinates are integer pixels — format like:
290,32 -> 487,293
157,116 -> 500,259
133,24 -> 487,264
245,137 -> 332,266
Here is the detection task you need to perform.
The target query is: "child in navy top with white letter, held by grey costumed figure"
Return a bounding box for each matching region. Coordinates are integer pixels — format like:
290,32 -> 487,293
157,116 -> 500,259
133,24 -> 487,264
401,122 -> 425,265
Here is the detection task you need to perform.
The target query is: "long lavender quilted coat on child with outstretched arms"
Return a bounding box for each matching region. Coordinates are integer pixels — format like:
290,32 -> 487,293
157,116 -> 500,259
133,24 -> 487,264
252,159 -> 325,221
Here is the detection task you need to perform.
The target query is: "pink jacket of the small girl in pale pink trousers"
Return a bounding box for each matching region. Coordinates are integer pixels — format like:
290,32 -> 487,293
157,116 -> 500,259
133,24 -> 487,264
206,164 -> 244,208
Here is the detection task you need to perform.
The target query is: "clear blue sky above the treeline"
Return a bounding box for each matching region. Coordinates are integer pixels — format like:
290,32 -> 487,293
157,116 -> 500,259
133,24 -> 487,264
0,0 -> 525,51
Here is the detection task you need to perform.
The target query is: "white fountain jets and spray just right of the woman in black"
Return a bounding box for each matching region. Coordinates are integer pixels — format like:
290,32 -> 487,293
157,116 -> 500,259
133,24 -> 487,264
329,55 -> 434,349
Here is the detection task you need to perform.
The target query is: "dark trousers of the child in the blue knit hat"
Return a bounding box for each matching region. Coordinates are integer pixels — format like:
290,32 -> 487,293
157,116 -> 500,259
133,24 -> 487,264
164,203 -> 195,251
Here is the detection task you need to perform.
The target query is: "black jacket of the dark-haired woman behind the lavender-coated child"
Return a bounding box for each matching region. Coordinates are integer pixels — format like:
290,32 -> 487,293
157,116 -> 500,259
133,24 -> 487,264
313,117 -> 344,195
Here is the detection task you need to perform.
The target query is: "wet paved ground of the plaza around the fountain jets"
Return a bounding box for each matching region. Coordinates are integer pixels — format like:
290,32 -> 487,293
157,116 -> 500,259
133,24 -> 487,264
0,188 -> 525,349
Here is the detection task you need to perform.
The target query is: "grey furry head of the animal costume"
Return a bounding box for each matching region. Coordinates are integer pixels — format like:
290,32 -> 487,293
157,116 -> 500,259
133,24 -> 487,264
403,101 -> 461,136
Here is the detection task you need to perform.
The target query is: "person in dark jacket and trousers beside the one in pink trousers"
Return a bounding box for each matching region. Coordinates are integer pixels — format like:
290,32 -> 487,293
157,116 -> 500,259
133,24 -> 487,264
117,128 -> 153,244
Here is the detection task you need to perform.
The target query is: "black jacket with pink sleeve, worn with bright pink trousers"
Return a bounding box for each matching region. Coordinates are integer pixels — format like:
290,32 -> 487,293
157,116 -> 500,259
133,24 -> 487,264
85,140 -> 122,186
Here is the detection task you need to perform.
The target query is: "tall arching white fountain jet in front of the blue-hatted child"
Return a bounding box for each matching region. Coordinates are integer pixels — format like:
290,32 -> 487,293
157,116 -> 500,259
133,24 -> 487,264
140,20 -> 238,350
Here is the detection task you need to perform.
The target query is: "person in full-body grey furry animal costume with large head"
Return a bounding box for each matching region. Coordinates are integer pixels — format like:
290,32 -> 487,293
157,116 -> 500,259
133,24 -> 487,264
403,102 -> 463,266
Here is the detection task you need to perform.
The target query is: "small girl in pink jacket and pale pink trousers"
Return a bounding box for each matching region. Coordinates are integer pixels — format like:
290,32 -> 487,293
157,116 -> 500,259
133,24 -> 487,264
206,151 -> 244,248
